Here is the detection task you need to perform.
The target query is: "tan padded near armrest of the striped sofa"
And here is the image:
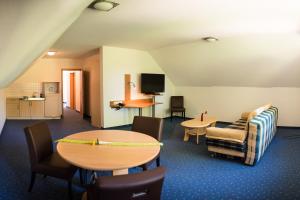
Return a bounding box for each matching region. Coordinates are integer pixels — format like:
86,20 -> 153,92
206,127 -> 247,143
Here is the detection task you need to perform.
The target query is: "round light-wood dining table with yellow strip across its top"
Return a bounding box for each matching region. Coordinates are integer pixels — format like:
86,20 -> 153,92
57,130 -> 160,175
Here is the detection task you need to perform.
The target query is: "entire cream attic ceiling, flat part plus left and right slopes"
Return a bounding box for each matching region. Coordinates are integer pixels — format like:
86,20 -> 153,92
4,0 -> 300,87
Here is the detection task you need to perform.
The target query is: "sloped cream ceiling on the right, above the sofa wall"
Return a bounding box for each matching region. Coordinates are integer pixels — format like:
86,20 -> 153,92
151,34 -> 300,87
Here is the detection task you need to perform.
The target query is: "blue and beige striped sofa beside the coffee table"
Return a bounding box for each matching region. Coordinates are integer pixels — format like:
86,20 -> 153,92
206,104 -> 278,165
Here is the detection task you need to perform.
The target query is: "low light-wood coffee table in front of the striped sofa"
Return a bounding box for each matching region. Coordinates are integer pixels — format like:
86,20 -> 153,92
181,117 -> 217,144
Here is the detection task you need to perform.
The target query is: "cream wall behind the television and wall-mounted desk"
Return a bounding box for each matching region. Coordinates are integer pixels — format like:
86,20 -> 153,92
103,46 -> 174,127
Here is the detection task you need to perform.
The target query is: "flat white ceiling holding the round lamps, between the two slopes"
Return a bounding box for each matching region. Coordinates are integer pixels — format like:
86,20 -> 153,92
52,0 -> 300,56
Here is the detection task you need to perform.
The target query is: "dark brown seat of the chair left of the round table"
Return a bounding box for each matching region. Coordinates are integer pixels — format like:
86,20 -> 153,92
33,152 -> 77,179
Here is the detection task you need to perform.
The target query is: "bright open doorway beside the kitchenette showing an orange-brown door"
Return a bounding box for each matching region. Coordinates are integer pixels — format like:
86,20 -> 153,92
62,69 -> 84,115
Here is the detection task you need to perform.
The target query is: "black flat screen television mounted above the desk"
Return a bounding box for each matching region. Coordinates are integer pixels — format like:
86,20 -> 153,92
141,73 -> 165,94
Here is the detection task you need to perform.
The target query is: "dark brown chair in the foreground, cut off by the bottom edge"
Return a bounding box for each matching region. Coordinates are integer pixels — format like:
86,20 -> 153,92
82,167 -> 165,200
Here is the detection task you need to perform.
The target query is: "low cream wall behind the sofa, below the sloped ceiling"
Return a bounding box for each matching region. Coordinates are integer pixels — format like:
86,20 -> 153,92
176,87 -> 300,127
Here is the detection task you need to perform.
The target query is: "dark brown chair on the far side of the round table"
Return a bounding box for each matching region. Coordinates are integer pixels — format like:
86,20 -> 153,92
131,116 -> 163,171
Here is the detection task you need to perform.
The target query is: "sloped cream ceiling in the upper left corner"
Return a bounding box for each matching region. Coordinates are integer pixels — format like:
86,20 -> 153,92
0,0 -> 91,88
